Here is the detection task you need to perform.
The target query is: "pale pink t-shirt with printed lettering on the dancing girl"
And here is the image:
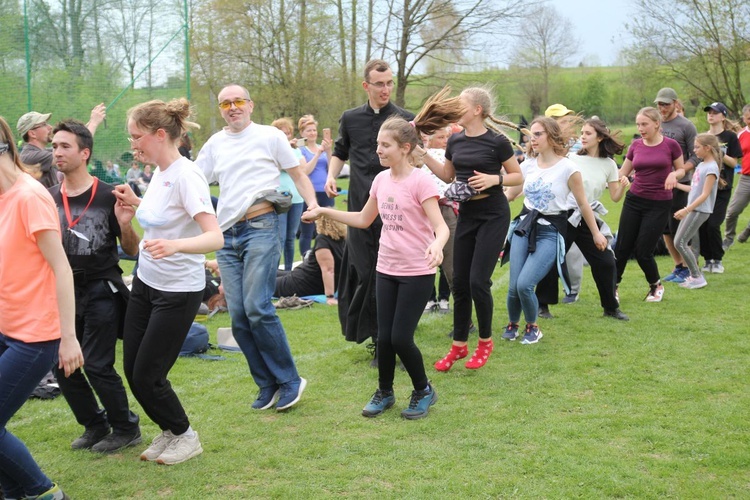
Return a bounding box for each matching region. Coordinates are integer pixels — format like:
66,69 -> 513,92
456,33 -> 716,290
370,168 -> 439,276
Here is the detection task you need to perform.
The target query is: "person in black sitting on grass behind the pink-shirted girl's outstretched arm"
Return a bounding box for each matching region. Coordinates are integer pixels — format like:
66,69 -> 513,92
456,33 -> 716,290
274,216 -> 346,306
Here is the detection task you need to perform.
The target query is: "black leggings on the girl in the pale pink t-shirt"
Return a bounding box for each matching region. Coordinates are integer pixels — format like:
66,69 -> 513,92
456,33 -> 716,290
375,272 -> 435,391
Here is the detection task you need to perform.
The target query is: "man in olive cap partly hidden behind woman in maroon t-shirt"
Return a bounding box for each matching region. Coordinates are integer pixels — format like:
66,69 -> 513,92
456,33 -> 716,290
654,87 -> 698,283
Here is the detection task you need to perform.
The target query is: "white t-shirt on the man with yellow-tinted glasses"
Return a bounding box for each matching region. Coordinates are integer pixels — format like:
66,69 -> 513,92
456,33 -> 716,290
195,122 -> 299,231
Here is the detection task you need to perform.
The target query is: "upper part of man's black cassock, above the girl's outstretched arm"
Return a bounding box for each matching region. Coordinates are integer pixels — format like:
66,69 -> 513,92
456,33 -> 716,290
333,102 -> 414,212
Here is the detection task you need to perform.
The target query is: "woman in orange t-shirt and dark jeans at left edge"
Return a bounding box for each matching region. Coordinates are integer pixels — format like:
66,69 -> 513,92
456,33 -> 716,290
0,118 -> 83,500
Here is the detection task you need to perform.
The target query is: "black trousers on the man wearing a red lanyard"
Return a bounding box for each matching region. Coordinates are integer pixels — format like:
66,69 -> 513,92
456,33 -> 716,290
55,280 -> 138,433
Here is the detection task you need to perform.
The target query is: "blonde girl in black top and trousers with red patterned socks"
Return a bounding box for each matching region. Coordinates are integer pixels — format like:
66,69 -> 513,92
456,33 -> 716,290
425,87 -> 523,372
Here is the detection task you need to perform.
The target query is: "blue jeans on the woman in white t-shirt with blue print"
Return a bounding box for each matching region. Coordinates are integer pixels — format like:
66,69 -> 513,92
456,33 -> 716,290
508,224 -> 557,324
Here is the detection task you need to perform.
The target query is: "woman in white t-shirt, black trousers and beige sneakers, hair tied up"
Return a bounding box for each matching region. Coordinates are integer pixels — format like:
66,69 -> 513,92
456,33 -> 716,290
115,99 -> 224,465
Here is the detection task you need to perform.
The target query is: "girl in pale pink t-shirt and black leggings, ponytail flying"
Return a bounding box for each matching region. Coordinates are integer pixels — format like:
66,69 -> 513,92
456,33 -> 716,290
302,112 -> 452,419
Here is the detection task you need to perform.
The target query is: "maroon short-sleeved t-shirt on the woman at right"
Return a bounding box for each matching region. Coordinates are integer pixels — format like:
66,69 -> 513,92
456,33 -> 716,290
627,137 -> 682,200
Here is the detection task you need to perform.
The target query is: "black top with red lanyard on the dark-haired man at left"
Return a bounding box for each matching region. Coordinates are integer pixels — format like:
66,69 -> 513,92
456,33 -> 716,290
49,181 -> 122,283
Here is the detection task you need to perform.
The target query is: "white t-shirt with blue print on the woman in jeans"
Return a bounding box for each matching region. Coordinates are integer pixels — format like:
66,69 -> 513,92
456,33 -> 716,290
521,154 -> 578,215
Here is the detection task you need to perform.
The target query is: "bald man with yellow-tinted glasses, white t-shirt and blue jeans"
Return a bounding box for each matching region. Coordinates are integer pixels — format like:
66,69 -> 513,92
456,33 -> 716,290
195,85 -> 318,411
